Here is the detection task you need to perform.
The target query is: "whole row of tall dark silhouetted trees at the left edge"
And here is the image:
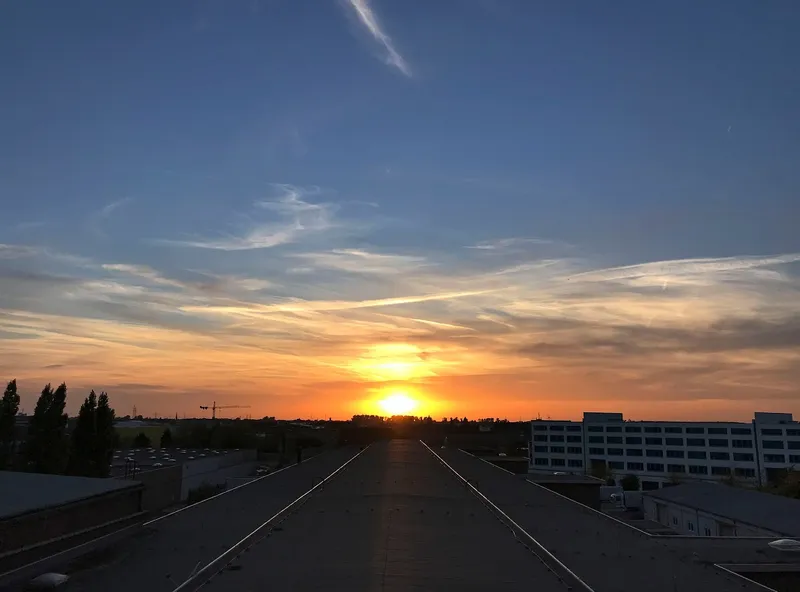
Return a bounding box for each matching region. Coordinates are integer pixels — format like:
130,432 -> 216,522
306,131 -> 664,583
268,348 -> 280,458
0,380 -> 117,477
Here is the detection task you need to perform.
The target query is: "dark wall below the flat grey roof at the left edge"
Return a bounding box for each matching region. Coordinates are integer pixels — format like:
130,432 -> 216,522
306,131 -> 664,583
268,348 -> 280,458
0,487 -> 142,554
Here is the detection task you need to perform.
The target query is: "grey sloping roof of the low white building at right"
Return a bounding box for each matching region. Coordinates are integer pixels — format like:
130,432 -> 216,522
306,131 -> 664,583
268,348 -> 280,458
645,482 -> 800,536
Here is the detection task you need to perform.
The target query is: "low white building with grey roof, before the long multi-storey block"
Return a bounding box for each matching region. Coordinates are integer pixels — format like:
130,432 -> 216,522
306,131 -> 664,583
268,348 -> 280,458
642,482 -> 800,538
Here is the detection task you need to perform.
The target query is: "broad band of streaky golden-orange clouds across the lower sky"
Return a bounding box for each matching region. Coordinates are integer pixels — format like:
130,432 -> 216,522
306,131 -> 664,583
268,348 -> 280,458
0,200 -> 800,415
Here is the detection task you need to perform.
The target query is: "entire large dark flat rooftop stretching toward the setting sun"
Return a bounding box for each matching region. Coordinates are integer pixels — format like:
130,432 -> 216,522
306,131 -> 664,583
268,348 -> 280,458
7,440 -> 780,592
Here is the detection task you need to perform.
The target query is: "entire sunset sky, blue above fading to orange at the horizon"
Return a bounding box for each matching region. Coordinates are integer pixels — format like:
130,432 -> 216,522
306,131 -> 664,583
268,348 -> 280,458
0,0 -> 800,421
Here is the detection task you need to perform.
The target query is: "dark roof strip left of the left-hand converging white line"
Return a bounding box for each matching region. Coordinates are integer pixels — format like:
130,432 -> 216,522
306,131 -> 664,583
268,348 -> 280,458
63,448 -> 358,592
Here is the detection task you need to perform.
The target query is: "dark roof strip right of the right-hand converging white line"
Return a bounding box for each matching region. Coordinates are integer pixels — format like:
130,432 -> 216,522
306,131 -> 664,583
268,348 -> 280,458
436,449 -> 764,592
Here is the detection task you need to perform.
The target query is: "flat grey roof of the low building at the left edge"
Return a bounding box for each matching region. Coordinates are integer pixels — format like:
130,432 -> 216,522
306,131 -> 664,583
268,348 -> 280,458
0,471 -> 140,519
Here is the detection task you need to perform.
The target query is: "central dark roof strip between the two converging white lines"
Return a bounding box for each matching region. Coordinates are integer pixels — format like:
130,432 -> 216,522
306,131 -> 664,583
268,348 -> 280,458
202,440 -> 567,592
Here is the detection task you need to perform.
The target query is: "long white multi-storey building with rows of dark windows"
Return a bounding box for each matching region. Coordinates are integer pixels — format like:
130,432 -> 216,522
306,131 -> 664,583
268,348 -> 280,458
529,412 -> 800,490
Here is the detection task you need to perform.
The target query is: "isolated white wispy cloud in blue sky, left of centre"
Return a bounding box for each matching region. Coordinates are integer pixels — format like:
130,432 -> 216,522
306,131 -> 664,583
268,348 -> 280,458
151,184 -> 337,251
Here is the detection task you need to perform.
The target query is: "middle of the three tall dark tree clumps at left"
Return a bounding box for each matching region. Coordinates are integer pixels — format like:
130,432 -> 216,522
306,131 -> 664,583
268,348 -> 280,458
25,383 -> 67,474
